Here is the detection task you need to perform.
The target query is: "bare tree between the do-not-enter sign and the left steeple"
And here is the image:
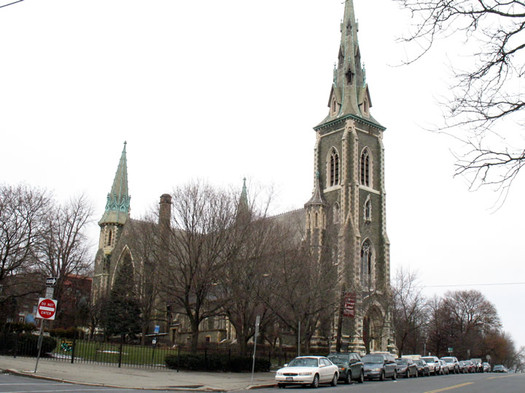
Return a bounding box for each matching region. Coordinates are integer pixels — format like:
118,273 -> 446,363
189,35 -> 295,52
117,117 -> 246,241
35,195 -> 93,321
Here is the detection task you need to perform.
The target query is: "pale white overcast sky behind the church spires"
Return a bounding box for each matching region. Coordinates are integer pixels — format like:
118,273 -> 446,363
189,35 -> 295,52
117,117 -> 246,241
0,0 -> 525,346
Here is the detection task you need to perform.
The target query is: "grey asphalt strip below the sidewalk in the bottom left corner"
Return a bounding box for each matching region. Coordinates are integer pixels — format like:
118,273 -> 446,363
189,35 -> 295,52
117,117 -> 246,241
0,374 -> 174,393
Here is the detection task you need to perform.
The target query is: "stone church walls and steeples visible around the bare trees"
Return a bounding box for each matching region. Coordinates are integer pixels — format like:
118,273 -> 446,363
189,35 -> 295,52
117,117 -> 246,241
93,0 -> 395,353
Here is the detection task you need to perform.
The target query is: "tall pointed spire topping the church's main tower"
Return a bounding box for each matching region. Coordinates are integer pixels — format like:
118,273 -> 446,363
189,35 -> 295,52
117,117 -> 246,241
315,0 -> 382,129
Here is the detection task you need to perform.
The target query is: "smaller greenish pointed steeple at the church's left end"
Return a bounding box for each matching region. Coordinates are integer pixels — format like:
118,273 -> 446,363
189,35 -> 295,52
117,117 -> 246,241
99,142 -> 131,225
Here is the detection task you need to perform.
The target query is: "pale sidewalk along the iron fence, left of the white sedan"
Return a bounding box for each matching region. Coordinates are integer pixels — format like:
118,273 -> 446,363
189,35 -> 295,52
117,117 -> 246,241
0,356 -> 275,392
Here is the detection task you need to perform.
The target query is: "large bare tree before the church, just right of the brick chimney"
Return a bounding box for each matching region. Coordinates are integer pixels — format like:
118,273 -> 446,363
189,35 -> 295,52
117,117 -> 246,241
160,183 -> 237,351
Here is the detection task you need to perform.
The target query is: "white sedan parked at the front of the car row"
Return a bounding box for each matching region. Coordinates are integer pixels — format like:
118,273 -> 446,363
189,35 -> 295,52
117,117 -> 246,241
275,356 -> 339,388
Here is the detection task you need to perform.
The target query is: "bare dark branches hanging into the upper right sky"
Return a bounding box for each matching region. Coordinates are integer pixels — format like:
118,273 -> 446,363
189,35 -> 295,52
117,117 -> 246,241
394,0 -> 525,195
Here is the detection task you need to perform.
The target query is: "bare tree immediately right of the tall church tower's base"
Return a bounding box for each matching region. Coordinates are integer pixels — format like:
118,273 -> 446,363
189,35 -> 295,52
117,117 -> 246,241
392,268 -> 428,356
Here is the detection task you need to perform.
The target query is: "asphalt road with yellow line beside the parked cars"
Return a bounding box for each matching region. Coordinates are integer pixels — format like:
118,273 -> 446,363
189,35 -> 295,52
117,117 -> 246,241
252,373 -> 525,393
